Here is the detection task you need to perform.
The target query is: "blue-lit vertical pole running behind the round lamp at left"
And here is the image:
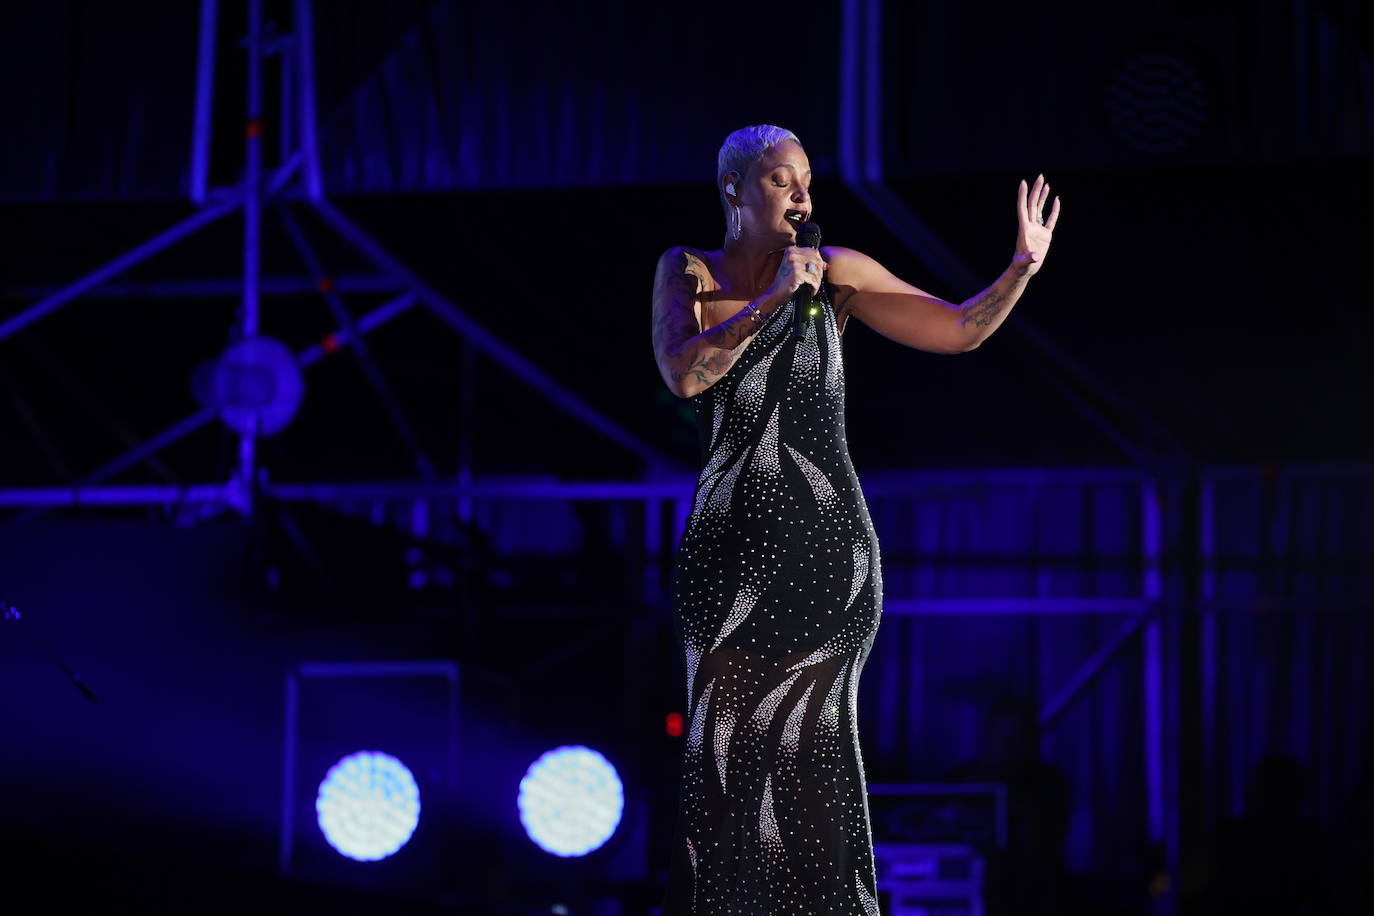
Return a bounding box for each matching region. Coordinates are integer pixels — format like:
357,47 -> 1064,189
239,0 -> 262,514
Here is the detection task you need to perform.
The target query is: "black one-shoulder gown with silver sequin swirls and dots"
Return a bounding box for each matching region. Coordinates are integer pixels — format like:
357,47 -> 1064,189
664,284 -> 882,916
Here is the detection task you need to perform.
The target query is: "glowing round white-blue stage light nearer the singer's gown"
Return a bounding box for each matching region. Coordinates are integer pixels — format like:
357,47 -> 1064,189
518,746 -> 625,857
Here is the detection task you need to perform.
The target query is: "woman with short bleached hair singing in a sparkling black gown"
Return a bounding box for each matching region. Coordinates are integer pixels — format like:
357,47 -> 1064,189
654,125 -> 1059,916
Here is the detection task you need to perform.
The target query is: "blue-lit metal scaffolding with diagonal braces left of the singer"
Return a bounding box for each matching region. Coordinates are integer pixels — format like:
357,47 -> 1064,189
0,0 -> 676,522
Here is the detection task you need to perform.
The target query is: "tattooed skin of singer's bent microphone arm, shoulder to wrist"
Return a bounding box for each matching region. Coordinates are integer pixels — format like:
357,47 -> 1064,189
654,251 -> 758,386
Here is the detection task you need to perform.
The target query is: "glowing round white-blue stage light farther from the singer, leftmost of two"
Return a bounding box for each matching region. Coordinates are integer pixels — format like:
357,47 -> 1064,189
315,751 -> 420,862
